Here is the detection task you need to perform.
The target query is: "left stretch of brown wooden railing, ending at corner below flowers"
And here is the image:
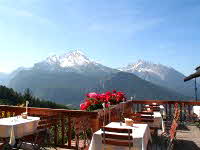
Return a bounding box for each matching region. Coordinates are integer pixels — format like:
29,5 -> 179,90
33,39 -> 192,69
0,105 -> 99,148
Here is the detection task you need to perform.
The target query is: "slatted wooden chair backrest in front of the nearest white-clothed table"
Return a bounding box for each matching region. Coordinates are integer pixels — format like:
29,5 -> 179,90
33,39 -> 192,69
101,127 -> 133,149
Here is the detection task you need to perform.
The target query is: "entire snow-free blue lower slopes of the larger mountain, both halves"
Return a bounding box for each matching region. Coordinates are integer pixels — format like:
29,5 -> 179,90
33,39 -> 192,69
11,71 -> 190,105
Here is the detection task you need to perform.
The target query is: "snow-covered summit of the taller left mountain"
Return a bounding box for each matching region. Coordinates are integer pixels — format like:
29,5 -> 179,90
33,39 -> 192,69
34,50 -> 117,73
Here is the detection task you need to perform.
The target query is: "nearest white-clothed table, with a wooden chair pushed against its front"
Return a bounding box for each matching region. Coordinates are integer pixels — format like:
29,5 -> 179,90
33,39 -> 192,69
89,122 -> 151,150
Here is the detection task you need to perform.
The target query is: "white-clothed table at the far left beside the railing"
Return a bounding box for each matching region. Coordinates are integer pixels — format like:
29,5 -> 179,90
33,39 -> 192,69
0,116 -> 40,145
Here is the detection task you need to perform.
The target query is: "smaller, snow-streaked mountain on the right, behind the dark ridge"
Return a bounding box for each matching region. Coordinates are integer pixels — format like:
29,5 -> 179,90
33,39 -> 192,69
120,60 -> 198,96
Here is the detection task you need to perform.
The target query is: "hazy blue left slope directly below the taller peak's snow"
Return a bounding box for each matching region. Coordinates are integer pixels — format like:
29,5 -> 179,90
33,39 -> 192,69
10,70 -> 101,104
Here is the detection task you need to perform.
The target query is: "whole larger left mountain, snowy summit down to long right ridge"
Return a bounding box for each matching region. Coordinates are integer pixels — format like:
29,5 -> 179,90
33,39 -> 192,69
9,51 -> 192,105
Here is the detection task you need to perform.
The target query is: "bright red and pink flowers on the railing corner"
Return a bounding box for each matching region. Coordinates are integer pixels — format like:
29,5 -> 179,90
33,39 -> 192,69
80,90 -> 126,111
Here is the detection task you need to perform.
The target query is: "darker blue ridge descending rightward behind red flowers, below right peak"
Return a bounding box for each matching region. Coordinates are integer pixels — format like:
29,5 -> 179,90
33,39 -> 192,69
105,72 -> 191,100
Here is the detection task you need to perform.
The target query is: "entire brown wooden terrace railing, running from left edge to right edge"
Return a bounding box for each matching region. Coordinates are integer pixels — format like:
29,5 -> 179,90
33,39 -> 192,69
0,100 -> 200,148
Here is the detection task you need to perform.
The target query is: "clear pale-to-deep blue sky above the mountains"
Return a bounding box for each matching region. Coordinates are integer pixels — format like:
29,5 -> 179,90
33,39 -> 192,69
0,0 -> 200,75
